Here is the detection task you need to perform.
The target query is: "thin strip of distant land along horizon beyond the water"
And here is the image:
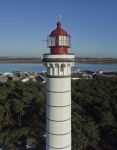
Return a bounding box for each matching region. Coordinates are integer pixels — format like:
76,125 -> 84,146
0,58 -> 117,64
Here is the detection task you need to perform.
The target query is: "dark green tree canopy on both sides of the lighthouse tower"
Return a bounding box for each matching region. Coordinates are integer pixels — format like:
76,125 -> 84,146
0,77 -> 117,150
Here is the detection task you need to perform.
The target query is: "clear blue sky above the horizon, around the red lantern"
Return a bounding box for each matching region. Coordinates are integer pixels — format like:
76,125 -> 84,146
0,0 -> 117,57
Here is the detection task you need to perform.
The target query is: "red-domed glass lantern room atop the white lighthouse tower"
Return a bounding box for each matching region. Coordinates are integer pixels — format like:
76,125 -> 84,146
47,21 -> 71,54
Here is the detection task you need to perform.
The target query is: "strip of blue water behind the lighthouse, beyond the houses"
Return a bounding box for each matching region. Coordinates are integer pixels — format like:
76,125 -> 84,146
0,64 -> 117,72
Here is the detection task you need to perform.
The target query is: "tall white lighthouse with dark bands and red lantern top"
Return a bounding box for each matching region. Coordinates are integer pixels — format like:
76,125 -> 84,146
43,20 -> 75,150
